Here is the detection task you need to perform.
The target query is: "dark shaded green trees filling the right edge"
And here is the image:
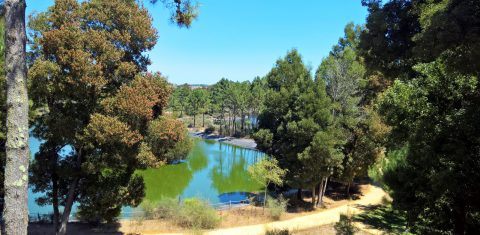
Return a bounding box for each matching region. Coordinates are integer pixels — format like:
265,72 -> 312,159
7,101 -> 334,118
360,0 -> 480,234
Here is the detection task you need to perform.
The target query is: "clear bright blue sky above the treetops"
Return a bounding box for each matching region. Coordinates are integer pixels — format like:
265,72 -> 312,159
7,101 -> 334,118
27,0 -> 367,84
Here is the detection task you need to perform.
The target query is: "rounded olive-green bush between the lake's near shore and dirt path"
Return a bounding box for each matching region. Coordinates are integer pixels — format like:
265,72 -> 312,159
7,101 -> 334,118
176,198 -> 220,229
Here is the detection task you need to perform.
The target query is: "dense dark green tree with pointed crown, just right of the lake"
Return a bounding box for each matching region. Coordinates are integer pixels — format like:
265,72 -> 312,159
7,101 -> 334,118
254,50 -> 338,190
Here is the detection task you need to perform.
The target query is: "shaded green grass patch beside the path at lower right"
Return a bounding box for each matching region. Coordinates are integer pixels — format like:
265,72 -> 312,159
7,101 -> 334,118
353,205 -> 408,234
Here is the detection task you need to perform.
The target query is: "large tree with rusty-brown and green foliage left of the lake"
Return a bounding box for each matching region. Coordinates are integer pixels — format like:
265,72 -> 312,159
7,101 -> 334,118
29,0 -> 186,226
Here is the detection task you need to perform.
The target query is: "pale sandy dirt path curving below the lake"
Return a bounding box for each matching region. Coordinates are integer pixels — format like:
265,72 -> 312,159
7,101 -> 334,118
138,185 -> 386,235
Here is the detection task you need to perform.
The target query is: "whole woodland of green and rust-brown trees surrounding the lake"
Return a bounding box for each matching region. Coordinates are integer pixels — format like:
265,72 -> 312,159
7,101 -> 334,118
0,0 -> 480,234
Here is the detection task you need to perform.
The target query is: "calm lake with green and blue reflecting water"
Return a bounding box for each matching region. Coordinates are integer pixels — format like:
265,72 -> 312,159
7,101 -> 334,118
28,138 -> 265,218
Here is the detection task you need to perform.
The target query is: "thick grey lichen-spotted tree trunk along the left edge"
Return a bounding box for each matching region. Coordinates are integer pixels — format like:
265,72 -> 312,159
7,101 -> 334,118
3,0 -> 30,235
